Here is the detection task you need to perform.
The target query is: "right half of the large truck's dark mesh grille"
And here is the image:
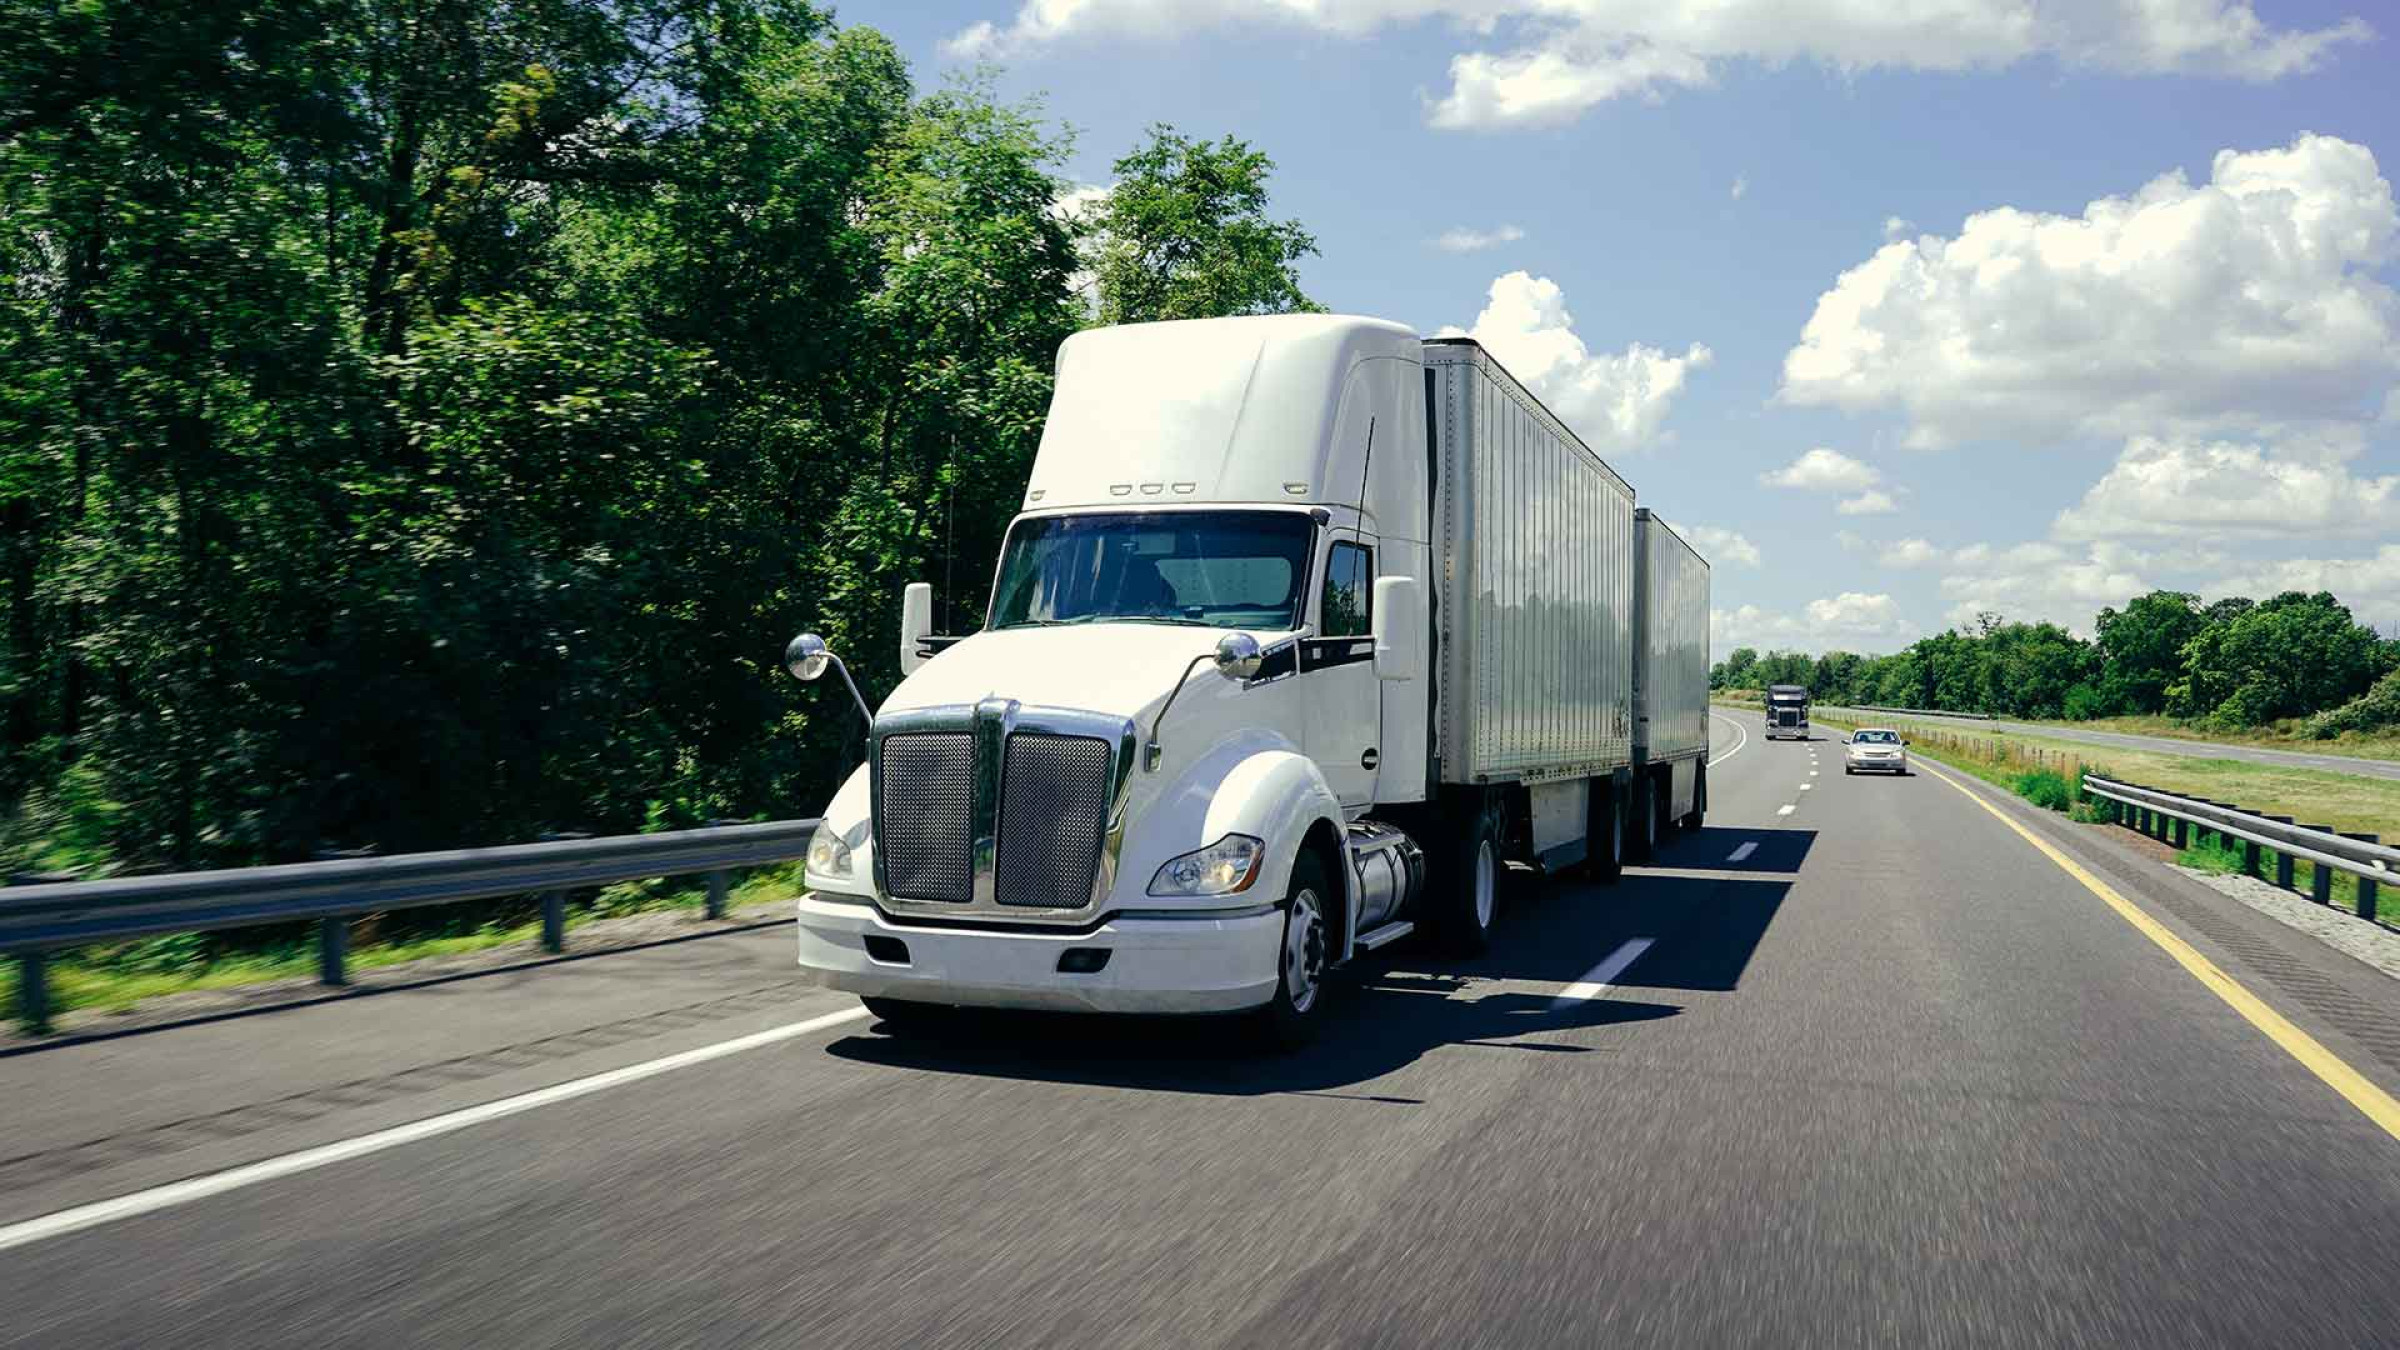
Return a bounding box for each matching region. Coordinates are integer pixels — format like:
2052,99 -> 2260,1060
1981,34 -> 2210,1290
988,730 -> 1109,908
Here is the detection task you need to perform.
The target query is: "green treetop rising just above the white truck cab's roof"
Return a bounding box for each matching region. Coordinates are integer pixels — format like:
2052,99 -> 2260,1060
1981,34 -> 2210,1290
1090,125 -> 1322,324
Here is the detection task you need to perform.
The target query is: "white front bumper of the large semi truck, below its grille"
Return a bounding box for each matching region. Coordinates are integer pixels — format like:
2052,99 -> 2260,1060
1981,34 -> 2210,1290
799,894 -> 1284,1014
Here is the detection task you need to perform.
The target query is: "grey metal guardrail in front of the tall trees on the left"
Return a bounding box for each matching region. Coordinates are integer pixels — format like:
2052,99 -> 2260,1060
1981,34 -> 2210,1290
0,819 -> 816,1031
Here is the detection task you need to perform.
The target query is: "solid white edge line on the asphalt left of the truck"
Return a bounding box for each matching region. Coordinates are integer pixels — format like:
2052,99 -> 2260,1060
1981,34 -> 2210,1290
0,1006 -> 866,1252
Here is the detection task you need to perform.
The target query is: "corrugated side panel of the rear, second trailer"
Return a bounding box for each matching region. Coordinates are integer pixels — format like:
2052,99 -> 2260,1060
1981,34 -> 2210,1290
1634,507 -> 1709,764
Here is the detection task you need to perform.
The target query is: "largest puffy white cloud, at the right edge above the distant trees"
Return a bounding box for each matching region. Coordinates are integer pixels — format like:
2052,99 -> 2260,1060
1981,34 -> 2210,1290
1781,133 -> 2400,447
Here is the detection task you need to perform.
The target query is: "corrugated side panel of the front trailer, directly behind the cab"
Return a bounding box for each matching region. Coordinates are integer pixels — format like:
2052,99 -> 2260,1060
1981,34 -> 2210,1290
1426,341 -> 1634,783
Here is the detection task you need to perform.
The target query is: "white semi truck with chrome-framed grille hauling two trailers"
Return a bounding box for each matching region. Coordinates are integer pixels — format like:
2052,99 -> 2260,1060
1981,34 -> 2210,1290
787,315 -> 1709,1040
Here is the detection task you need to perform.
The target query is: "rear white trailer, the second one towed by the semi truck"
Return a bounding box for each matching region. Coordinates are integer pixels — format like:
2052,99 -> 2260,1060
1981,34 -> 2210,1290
1627,507 -> 1709,858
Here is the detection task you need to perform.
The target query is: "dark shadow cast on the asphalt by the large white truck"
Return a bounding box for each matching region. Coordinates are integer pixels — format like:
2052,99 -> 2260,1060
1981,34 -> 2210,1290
826,859 -> 1788,1105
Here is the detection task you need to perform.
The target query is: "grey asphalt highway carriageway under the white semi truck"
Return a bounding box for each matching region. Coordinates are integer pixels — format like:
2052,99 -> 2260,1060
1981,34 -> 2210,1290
0,713 -> 2400,1350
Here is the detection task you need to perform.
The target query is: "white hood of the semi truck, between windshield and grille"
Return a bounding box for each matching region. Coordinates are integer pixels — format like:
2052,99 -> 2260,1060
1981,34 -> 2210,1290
878,622 -> 1284,721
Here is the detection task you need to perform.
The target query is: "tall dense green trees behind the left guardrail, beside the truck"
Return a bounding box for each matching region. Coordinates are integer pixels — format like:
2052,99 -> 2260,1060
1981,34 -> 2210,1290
0,0 -> 1313,867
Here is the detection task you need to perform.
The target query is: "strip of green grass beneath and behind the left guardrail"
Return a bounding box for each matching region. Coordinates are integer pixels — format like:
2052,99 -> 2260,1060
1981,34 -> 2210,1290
0,862 -> 802,1014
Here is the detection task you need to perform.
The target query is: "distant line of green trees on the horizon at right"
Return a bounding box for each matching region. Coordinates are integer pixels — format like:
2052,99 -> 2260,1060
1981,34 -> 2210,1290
1709,591 -> 2400,737
